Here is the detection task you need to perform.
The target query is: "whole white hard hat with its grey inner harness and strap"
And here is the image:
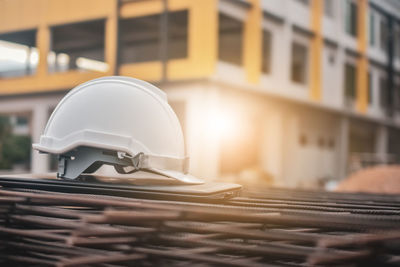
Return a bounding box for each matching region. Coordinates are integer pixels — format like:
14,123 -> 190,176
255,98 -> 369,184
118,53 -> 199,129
33,76 -> 203,184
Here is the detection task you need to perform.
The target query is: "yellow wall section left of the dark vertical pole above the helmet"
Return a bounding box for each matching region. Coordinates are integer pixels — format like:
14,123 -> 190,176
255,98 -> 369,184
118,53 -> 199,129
0,0 -> 117,95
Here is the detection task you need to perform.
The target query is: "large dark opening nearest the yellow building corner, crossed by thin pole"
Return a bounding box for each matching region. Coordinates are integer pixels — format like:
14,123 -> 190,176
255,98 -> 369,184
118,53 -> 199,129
119,10 -> 188,64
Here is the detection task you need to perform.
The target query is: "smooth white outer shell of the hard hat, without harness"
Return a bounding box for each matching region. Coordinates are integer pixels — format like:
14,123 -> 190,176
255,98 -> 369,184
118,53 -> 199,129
33,76 -> 185,158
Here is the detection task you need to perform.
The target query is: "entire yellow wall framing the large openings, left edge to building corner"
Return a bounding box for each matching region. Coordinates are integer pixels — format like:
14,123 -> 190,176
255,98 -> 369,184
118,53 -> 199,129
0,0 -> 218,95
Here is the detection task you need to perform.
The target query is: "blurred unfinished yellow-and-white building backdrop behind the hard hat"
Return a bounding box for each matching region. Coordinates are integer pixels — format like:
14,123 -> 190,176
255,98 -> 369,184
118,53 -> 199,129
0,0 -> 400,193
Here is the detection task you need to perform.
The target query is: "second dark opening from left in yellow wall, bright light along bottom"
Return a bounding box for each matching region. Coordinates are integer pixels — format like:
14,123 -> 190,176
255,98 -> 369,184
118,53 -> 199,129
47,20 -> 108,72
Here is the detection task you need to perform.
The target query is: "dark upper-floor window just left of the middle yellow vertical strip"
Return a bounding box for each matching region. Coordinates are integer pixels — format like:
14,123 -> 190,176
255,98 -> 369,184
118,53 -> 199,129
291,42 -> 308,84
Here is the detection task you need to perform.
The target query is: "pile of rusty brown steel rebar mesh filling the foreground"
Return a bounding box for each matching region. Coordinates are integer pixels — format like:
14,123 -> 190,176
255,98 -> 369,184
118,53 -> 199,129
0,179 -> 400,266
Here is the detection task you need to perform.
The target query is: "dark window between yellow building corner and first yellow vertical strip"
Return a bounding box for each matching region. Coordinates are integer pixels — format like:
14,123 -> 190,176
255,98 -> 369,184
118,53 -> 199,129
218,14 -> 243,65
